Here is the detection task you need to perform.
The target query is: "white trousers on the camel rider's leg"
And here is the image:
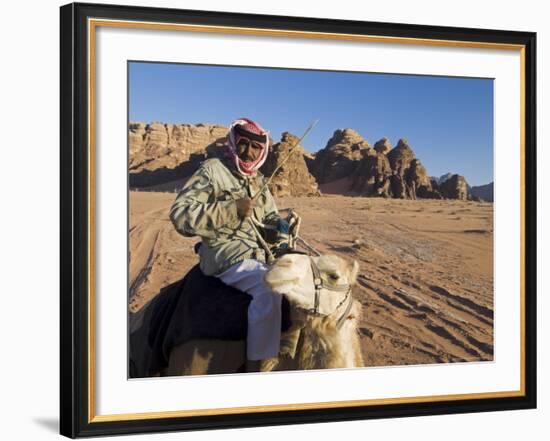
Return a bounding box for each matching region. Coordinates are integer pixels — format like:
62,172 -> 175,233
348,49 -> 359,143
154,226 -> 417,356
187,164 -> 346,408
216,259 -> 282,360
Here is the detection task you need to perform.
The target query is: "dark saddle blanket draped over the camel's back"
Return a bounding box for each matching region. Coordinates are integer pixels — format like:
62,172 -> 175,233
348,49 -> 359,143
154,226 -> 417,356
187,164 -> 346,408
129,265 -> 290,378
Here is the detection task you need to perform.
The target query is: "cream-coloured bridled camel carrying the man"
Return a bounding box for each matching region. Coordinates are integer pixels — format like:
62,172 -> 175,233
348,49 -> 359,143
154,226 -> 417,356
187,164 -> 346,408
159,254 -> 363,376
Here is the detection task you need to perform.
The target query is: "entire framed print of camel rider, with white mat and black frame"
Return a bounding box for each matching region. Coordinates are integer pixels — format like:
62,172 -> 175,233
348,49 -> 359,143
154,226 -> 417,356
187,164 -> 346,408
60,4 -> 536,438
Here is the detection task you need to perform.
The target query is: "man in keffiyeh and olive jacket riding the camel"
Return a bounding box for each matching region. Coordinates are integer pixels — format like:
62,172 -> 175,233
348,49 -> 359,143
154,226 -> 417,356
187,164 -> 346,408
170,118 -> 289,370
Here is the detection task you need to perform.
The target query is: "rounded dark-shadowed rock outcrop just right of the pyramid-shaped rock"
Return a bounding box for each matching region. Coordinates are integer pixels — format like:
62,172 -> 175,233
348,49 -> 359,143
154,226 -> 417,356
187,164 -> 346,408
311,129 -> 371,184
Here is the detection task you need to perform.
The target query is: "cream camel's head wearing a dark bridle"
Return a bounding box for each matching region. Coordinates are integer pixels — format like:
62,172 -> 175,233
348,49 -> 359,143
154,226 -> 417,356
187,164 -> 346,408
265,254 -> 359,316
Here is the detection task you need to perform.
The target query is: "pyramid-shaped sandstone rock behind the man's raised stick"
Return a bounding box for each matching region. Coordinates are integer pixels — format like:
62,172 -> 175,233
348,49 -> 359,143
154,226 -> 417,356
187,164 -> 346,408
260,132 -> 321,197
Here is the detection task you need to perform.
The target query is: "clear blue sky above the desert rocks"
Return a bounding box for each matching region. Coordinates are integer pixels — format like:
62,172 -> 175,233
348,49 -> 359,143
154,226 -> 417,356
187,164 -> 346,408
129,62 -> 493,185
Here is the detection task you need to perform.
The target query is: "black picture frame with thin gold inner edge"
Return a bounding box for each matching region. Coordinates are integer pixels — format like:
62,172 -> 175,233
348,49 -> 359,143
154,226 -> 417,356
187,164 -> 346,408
60,3 -> 537,438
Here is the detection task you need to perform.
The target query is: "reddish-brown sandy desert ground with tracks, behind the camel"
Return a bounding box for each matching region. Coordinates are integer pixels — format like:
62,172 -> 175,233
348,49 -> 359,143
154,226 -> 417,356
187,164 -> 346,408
129,192 -> 493,366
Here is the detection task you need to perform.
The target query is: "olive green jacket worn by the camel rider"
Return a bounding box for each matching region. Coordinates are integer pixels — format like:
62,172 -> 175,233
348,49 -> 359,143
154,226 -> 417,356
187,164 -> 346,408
170,158 -> 279,275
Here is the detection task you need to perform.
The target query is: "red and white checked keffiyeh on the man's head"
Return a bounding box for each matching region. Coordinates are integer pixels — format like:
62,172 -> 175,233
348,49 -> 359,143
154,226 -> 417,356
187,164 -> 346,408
227,118 -> 269,176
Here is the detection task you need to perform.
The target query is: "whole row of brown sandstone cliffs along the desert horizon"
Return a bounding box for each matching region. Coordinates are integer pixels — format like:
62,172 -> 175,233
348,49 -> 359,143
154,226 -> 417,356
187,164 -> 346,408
128,122 -> 478,200
